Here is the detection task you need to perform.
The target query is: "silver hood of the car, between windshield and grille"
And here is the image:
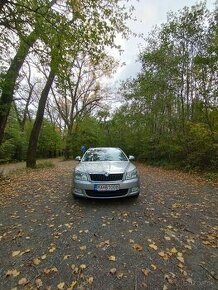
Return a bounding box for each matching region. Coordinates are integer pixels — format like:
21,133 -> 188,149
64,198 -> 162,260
75,161 -> 135,174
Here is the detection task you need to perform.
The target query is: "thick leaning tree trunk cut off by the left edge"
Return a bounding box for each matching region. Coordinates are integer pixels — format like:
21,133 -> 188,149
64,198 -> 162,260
0,31 -> 37,145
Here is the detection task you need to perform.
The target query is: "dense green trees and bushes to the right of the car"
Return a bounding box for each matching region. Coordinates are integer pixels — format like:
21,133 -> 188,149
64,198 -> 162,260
108,4 -> 218,171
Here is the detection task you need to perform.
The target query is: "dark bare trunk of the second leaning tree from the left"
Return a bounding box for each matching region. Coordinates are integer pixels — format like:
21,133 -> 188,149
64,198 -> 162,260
26,70 -> 55,168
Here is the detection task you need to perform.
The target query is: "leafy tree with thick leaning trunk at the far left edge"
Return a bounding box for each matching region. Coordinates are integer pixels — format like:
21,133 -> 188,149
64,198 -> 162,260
0,0 -> 56,144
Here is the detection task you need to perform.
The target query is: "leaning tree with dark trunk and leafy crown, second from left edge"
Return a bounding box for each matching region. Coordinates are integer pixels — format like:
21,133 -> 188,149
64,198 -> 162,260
24,0 -> 132,168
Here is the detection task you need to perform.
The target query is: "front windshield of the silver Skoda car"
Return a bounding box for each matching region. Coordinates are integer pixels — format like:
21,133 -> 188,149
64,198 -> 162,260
82,148 -> 128,162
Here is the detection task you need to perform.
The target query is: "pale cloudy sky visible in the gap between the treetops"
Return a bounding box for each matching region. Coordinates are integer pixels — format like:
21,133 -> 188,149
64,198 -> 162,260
110,0 -> 216,86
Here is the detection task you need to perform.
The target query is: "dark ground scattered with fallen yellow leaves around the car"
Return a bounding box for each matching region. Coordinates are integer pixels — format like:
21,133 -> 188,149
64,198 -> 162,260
0,161 -> 218,290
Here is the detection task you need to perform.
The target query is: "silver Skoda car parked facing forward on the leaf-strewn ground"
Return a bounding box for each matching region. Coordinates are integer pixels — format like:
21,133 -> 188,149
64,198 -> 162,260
72,147 -> 140,198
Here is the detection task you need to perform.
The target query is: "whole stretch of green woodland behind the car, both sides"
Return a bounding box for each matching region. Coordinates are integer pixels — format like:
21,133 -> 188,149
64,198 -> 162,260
0,0 -> 218,172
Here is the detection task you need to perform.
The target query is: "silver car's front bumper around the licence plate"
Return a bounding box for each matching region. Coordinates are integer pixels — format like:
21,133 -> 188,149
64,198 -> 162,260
72,178 -> 140,199
